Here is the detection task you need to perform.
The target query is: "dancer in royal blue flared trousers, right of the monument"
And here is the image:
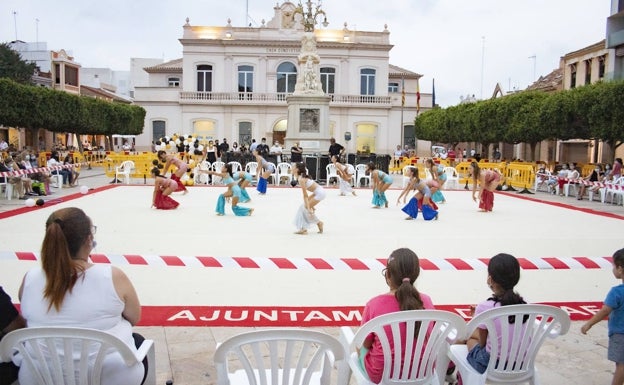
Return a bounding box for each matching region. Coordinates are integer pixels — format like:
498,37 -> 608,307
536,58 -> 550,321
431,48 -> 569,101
397,167 -> 438,221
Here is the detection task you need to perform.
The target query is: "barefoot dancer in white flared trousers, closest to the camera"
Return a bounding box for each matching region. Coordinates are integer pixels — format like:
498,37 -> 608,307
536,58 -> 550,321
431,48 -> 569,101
292,163 -> 325,234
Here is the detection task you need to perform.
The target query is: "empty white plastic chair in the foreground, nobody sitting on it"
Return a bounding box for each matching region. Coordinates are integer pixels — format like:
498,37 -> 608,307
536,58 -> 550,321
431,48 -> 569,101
214,328 -> 346,385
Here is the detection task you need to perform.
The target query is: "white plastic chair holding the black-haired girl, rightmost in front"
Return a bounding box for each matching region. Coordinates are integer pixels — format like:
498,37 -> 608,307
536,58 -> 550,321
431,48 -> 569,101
449,304 -> 570,385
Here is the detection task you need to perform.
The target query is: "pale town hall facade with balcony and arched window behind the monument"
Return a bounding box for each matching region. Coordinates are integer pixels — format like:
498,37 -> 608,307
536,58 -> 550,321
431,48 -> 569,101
134,2 -> 431,154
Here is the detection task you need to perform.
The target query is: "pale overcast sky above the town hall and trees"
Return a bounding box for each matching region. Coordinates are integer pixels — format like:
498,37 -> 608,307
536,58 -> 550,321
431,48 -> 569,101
0,0 -> 611,107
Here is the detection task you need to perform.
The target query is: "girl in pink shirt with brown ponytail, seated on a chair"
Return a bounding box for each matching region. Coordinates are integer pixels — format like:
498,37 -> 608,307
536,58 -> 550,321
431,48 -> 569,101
358,248 -> 435,384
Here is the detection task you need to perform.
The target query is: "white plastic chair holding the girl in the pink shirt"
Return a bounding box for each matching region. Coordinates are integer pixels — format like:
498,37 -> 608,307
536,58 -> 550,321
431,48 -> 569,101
340,310 -> 466,385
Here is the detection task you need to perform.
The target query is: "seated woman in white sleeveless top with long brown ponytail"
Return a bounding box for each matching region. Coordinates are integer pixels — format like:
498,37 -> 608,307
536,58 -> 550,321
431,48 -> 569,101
19,207 -> 145,385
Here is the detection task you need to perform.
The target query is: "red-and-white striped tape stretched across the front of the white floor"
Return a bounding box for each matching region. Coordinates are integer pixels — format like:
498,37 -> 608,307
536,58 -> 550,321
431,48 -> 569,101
0,251 -> 612,271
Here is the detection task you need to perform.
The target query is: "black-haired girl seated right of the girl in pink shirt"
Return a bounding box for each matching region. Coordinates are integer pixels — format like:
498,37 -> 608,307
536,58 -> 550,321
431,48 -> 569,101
466,253 -> 526,373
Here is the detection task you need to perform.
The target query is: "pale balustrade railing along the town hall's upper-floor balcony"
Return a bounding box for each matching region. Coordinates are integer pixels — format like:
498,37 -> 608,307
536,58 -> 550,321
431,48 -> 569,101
180,91 -> 392,108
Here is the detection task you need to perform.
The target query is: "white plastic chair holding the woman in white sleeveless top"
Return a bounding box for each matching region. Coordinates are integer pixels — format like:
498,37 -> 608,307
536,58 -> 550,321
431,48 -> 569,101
0,327 -> 156,385
